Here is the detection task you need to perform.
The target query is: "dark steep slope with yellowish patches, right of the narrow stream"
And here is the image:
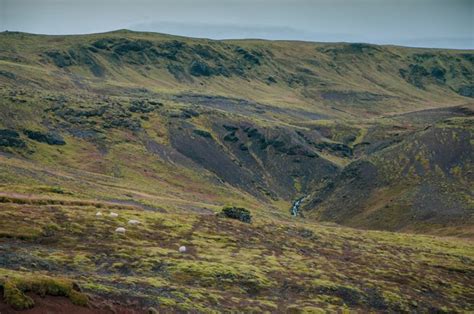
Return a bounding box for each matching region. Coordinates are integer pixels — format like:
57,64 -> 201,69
306,106 -> 474,236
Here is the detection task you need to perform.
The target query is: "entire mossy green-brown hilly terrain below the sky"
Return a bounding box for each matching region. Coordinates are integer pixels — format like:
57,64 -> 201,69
0,30 -> 474,312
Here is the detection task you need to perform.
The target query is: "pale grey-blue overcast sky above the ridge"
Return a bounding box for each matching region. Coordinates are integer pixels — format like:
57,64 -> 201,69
0,0 -> 474,49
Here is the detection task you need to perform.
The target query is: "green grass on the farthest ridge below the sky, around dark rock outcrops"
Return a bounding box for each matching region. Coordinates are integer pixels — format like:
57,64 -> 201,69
0,32 -> 470,120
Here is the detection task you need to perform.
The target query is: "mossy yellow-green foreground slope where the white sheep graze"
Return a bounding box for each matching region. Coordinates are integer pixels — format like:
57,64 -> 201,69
0,191 -> 474,312
